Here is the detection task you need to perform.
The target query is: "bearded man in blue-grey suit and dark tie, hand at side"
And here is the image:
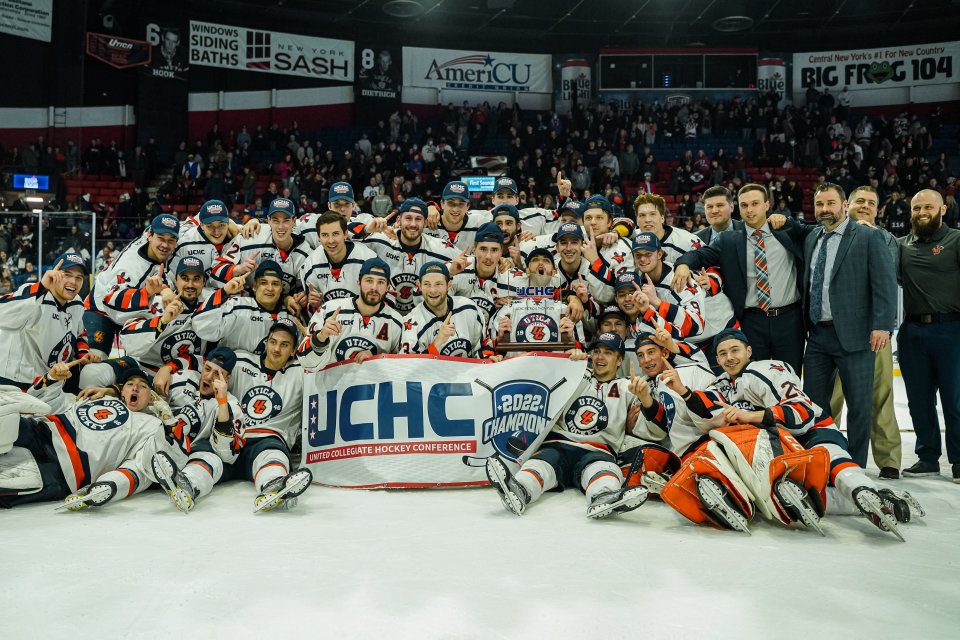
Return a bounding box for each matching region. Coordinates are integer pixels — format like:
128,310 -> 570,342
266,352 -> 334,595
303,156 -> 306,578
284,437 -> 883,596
803,182 -> 897,467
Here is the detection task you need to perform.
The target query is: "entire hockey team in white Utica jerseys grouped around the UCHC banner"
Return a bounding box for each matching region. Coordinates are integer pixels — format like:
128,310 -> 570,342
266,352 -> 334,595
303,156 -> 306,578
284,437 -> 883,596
0,176 -> 923,539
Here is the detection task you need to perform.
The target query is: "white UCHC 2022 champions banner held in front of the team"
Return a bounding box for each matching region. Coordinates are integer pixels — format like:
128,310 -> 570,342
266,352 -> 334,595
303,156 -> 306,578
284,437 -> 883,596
302,353 -> 587,489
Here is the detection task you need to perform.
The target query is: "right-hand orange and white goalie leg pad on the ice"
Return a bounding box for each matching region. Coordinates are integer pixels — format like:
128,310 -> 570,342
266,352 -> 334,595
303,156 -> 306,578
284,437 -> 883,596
710,425 -> 830,524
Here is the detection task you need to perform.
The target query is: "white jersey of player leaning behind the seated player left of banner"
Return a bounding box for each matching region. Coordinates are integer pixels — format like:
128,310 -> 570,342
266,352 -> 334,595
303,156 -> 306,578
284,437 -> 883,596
193,289 -> 291,353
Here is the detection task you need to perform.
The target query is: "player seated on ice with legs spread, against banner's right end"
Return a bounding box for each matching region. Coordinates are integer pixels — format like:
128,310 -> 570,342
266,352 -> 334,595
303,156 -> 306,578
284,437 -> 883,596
487,333 -> 666,518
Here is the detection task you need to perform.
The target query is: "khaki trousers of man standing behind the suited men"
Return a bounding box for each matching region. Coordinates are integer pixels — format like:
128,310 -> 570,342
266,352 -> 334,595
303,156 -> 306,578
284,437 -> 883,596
830,342 -> 901,469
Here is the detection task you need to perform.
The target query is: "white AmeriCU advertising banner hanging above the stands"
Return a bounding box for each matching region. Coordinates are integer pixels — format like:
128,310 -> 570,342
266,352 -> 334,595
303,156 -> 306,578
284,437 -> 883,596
403,47 -> 553,93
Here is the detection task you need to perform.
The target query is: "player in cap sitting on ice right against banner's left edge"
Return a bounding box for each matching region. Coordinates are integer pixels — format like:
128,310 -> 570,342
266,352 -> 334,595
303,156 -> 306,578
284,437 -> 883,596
156,320 -> 313,512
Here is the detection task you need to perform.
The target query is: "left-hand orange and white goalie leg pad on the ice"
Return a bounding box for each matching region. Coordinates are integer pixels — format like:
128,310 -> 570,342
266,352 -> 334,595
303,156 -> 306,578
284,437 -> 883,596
660,441 -> 754,524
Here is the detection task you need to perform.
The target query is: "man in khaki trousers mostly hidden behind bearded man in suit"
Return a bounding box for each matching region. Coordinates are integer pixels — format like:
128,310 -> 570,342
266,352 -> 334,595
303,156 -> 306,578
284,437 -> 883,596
830,185 -> 901,480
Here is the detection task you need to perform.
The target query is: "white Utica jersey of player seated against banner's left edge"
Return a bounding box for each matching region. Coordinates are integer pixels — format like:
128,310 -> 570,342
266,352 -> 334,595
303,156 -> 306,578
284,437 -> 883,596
230,351 -> 303,448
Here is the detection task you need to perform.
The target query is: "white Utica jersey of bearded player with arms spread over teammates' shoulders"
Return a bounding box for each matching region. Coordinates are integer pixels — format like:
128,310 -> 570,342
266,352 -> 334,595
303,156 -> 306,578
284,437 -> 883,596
365,233 -> 460,315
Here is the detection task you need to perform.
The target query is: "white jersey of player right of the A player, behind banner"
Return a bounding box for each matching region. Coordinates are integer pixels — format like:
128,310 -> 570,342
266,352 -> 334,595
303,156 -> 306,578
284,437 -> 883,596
400,296 -> 493,358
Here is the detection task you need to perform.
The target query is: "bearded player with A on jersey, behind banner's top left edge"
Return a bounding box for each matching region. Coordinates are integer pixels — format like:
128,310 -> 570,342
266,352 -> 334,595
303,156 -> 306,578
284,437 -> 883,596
297,258 -> 409,369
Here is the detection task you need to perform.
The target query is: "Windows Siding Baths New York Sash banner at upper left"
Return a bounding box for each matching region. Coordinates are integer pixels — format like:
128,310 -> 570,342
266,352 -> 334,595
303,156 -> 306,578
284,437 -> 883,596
190,20 -> 354,82
